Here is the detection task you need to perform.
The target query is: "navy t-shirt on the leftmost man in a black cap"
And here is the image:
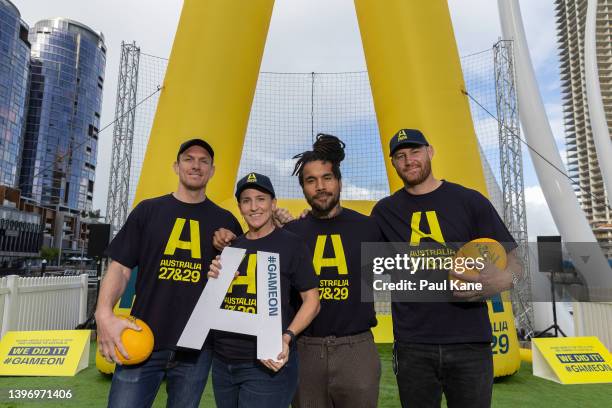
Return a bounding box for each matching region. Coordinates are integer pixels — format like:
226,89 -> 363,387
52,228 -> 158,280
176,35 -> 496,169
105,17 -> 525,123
107,194 -> 242,350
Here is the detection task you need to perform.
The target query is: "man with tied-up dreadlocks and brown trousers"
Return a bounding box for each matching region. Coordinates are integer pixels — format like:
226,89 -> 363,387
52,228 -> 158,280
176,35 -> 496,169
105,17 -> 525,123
214,134 -> 382,408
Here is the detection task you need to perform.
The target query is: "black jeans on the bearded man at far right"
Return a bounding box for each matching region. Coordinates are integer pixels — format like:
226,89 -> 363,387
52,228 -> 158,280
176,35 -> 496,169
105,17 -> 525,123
394,342 -> 493,408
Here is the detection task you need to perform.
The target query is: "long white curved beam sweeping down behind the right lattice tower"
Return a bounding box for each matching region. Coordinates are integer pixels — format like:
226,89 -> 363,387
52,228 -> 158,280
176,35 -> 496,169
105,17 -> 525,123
498,0 -> 612,301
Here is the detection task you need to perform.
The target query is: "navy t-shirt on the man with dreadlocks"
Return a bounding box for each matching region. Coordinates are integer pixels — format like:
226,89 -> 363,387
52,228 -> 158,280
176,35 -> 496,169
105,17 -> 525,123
284,208 -> 382,337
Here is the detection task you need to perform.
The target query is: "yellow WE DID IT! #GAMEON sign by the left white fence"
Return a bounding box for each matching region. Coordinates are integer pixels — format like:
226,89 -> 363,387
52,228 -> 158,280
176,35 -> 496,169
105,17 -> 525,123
0,330 -> 91,377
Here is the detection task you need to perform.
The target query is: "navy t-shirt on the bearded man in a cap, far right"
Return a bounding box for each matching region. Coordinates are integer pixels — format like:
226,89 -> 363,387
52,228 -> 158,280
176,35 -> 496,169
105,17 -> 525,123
372,181 -> 516,344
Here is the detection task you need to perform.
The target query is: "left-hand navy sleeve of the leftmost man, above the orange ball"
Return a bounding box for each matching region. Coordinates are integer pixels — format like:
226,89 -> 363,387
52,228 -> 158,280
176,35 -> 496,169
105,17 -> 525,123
106,203 -> 145,268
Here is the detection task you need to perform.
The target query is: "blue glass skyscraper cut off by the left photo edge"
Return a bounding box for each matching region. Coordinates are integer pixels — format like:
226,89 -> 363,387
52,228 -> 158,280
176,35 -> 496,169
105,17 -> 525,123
0,0 -> 30,188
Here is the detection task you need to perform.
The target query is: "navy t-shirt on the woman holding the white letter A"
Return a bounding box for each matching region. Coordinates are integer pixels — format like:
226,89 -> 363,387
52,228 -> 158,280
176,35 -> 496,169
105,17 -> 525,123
214,228 -> 317,362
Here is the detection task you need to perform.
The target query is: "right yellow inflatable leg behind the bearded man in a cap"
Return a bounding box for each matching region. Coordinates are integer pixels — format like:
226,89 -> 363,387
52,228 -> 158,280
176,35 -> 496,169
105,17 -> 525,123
355,0 -> 520,376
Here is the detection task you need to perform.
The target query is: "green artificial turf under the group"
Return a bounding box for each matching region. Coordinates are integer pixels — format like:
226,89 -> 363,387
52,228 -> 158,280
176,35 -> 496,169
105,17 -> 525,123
0,343 -> 612,408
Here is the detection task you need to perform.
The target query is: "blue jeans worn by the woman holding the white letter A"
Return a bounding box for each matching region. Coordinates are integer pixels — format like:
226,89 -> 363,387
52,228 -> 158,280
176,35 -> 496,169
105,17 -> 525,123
212,348 -> 298,408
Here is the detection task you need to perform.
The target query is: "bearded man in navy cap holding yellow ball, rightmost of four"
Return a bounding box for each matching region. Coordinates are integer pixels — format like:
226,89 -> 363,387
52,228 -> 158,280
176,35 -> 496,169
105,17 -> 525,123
372,129 -> 521,407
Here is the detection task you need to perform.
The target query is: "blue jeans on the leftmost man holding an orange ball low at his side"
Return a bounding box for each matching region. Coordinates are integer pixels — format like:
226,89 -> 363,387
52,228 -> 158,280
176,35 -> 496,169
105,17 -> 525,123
108,350 -> 212,408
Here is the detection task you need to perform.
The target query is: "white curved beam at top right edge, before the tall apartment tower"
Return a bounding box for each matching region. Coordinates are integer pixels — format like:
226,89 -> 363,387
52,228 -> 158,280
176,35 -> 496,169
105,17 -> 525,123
584,0 -> 612,205
